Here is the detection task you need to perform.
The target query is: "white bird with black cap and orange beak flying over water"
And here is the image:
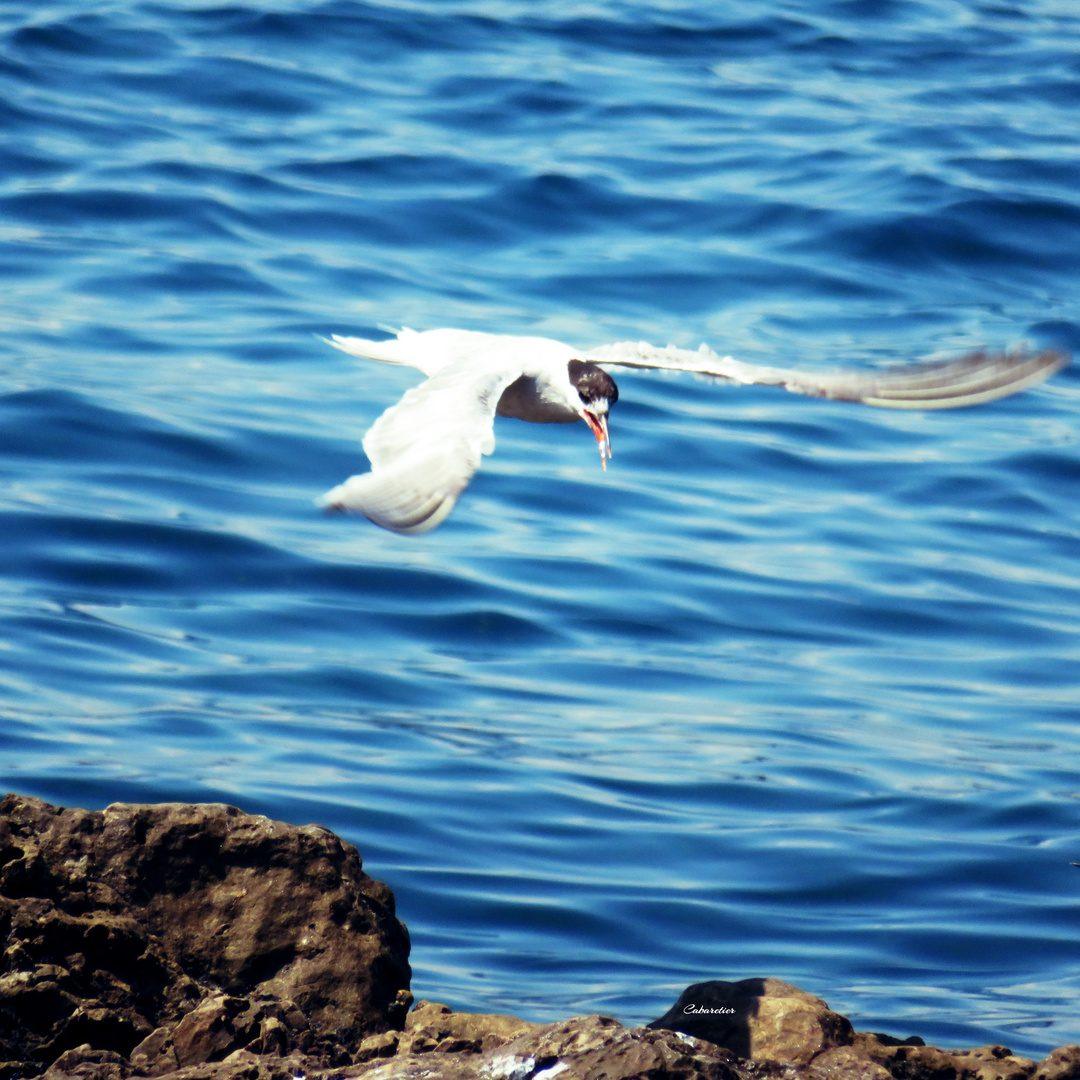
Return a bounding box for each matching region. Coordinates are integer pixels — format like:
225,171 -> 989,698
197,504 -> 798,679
320,329 -> 1069,532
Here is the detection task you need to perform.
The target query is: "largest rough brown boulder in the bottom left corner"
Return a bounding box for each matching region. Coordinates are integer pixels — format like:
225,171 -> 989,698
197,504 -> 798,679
0,795 -> 409,1078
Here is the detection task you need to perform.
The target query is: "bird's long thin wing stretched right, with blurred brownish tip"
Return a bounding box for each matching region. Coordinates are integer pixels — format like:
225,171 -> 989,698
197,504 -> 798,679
584,341 -> 1069,408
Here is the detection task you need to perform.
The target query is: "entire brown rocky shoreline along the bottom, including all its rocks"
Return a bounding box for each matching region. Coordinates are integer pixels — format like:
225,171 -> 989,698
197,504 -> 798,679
0,795 -> 1080,1080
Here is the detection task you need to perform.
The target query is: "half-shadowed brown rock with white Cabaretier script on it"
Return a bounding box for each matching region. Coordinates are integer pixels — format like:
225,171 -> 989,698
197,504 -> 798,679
648,978 -> 854,1065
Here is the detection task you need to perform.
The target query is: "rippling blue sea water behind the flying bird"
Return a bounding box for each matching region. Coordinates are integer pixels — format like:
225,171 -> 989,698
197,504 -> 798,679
0,0 -> 1080,1056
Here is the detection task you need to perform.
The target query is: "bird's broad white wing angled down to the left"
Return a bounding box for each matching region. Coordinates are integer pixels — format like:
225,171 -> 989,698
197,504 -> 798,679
320,364 -> 521,532
